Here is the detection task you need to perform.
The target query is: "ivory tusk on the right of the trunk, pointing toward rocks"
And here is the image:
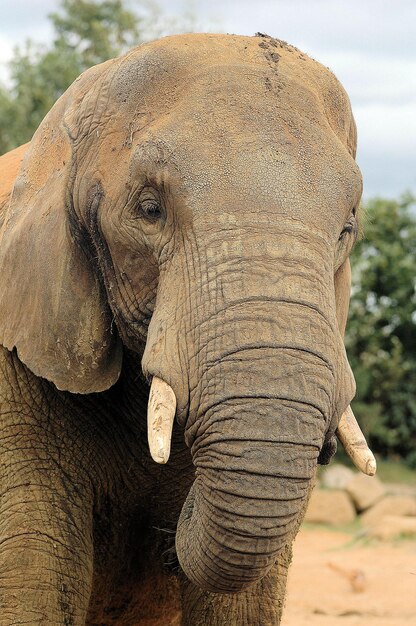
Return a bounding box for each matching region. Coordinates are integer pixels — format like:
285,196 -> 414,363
337,406 -> 377,476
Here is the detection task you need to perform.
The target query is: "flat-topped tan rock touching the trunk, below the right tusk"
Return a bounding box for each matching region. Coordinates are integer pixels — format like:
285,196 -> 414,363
304,489 -> 355,526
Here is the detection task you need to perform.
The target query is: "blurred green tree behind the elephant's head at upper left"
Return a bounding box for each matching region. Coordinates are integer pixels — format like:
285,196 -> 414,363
0,0 -> 142,154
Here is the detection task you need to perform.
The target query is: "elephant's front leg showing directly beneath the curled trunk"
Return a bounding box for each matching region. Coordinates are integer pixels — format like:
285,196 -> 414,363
181,545 -> 292,626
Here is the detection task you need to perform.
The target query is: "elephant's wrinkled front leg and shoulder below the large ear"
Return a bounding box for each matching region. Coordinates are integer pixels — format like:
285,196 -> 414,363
0,355 -> 93,626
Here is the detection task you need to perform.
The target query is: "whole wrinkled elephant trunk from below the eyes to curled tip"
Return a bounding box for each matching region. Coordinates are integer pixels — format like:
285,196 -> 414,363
143,241 -> 354,593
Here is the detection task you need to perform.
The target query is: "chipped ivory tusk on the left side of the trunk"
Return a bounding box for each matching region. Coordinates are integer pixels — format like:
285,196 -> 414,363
147,376 -> 176,463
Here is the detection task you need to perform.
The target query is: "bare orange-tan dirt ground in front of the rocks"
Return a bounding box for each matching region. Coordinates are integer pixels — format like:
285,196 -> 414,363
282,528 -> 416,626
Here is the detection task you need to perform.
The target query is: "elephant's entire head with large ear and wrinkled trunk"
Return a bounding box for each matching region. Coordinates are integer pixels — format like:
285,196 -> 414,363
0,35 -> 376,592
